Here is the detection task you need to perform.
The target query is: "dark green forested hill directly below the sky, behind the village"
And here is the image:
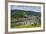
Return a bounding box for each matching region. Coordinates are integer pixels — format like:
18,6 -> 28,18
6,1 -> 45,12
11,10 -> 41,18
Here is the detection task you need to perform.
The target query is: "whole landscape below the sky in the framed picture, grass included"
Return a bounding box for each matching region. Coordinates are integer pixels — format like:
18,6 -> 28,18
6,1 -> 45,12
11,10 -> 41,28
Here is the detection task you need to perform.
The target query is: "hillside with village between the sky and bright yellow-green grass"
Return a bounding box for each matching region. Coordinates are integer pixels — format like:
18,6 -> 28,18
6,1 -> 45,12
11,10 -> 41,27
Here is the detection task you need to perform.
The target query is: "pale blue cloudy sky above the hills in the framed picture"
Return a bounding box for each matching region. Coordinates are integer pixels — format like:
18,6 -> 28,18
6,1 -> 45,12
11,5 -> 41,12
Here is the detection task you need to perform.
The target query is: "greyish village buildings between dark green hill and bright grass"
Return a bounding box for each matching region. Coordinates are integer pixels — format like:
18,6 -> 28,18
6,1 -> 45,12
16,16 -> 39,24
